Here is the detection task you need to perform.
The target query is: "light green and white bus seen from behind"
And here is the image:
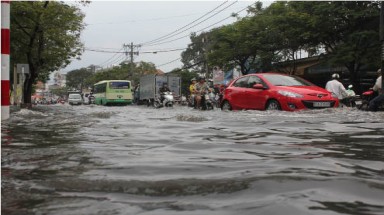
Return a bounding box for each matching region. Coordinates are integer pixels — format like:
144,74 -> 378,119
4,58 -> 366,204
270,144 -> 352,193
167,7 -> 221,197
93,80 -> 133,105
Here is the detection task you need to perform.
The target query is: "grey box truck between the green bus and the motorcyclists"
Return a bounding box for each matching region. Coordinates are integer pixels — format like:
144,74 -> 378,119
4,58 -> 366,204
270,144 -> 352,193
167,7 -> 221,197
138,74 -> 181,106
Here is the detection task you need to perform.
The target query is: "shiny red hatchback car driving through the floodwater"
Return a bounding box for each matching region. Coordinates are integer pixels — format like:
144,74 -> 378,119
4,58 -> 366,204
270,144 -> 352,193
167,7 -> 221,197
221,73 -> 339,111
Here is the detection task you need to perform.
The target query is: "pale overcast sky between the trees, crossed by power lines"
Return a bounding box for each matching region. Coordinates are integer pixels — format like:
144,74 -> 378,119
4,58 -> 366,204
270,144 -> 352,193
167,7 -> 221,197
62,0 -> 269,72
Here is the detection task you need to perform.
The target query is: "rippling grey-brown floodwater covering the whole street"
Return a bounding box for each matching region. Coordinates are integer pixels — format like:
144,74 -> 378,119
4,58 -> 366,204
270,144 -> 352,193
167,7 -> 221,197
1,104 -> 384,215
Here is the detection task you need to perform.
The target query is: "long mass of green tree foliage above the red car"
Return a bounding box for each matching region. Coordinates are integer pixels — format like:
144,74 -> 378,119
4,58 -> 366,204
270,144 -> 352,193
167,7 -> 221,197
182,1 -> 381,85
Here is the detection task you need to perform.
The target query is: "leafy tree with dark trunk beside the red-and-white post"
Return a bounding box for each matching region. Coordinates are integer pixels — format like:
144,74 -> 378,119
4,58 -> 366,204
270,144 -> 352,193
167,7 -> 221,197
11,1 -> 84,106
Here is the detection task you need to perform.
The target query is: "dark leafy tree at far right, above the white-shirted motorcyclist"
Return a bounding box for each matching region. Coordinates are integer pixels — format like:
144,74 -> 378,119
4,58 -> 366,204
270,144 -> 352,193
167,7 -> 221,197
289,1 -> 381,88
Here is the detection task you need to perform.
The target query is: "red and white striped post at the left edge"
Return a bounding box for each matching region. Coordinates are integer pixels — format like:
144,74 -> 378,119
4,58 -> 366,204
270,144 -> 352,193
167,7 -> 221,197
1,1 -> 11,120
